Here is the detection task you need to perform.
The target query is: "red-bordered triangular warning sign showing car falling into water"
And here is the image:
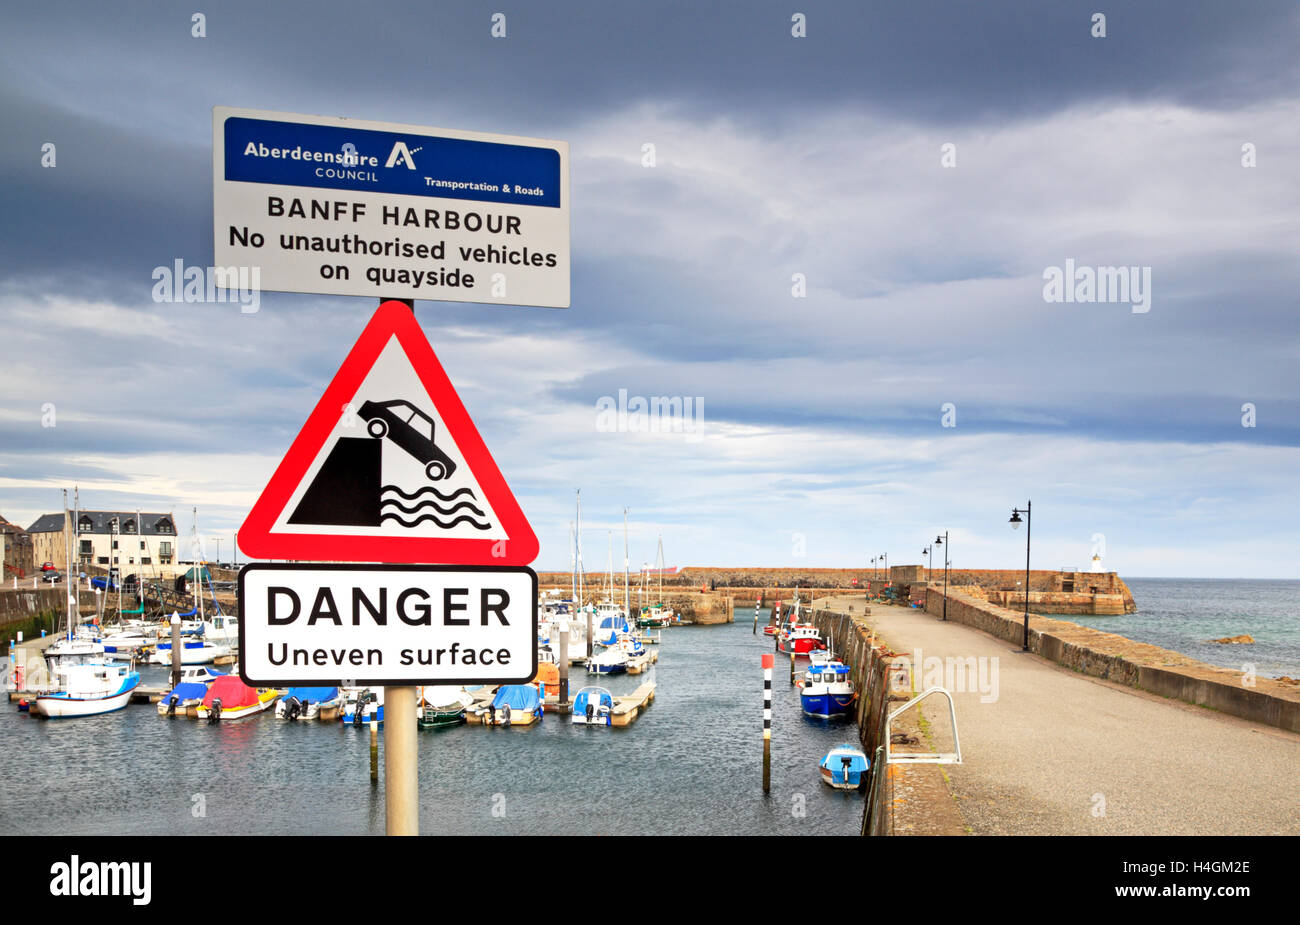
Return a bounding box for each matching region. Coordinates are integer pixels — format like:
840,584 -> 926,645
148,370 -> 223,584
238,301 -> 538,565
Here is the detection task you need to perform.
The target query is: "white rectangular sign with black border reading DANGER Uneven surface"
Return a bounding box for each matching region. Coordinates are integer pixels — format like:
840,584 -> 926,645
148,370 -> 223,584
239,563 -> 537,687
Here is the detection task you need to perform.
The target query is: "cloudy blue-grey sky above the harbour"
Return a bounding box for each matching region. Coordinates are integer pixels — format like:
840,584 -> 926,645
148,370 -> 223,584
0,0 -> 1300,578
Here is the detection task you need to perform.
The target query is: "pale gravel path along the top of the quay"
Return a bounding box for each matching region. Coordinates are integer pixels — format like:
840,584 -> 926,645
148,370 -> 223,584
821,598 -> 1300,835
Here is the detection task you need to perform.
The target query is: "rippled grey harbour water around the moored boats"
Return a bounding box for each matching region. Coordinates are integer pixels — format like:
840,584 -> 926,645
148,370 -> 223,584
0,613 -> 863,835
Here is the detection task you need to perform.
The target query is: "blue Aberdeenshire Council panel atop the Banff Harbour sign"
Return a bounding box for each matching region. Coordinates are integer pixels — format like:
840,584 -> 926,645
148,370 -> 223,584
225,117 -> 560,209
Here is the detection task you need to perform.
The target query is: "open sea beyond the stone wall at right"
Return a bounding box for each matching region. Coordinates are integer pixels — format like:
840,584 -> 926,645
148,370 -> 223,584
1062,578 -> 1300,678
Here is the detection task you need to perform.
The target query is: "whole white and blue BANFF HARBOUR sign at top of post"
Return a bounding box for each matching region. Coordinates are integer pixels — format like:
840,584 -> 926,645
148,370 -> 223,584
212,107 -> 569,308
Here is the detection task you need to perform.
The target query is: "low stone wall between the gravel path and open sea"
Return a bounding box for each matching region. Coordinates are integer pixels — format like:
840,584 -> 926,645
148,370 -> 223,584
926,587 -> 1300,733
